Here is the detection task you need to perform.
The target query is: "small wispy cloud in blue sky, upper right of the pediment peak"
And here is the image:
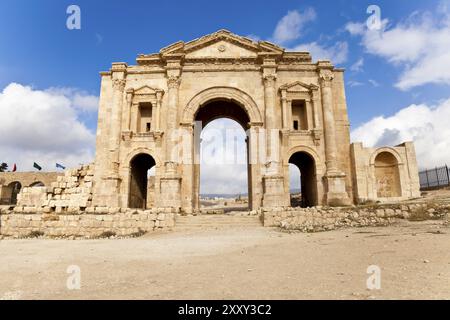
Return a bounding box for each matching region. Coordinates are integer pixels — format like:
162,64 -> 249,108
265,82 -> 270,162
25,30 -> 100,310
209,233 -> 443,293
271,8 -> 316,44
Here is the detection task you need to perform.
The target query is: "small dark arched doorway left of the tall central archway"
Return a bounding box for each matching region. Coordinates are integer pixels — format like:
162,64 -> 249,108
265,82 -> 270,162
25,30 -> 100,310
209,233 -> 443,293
128,153 -> 156,209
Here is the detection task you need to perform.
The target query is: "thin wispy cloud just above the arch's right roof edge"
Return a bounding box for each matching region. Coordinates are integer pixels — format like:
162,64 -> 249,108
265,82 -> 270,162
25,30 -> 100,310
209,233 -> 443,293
293,41 -> 348,64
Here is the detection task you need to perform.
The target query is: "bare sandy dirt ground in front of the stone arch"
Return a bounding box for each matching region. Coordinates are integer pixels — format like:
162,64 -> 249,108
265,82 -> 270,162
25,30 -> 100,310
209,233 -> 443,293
0,221 -> 450,299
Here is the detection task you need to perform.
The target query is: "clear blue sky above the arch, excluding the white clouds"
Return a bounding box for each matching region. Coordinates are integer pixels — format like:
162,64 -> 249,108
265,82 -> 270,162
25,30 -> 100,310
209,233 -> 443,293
0,0 -> 446,128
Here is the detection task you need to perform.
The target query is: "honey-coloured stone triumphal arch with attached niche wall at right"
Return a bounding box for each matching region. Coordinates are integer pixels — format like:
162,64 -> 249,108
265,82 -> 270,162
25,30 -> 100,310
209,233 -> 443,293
92,30 -> 419,213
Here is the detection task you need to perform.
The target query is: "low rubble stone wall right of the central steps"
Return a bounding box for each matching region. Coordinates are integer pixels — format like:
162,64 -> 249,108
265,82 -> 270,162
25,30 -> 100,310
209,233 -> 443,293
262,202 -> 450,232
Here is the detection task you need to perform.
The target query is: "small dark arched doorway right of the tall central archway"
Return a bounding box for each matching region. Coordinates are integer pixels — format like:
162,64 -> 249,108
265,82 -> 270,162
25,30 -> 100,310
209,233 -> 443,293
289,151 -> 318,208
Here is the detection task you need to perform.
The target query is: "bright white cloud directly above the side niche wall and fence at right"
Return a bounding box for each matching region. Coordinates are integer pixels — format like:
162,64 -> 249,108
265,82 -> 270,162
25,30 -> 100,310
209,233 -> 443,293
351,99 -> 450,168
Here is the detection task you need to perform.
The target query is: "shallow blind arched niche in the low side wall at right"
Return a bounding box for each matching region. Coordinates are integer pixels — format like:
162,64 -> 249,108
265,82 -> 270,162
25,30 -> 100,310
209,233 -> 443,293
375,151 -> 402,198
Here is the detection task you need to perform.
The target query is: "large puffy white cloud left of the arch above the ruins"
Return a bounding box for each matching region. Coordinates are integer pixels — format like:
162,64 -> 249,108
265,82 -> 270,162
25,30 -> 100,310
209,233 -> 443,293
0,83 -> 96,171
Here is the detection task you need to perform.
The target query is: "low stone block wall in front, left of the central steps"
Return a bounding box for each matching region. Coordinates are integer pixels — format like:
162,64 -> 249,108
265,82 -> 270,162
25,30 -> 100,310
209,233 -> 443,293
0,207 -> 176,238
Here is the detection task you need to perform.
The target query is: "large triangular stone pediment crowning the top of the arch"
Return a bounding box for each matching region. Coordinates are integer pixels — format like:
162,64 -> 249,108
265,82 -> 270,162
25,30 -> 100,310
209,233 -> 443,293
160,30 -> 284,59
